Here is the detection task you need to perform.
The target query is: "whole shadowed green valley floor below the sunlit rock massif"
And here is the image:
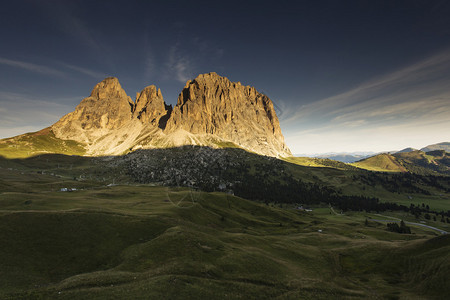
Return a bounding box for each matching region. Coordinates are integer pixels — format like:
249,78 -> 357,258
0,146 -> 450,299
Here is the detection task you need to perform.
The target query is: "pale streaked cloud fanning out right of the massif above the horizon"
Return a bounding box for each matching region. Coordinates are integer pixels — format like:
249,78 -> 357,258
282,51 -> 450,152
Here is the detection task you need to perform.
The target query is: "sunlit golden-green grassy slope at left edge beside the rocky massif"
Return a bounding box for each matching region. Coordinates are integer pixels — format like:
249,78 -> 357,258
0,128 -> 86,158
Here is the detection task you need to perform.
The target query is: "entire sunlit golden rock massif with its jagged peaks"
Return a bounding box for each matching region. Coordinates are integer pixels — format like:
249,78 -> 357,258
51,73 -> 292,157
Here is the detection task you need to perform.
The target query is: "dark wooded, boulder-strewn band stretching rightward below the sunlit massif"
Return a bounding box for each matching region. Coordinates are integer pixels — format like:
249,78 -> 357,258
123,146 -> 450,217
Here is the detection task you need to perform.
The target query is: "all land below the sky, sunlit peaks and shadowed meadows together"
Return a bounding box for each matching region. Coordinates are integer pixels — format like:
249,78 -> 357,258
0,72 -> 450,299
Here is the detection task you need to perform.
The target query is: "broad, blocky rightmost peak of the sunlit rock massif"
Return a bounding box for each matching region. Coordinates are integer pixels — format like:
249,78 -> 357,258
166,72 -> 291,156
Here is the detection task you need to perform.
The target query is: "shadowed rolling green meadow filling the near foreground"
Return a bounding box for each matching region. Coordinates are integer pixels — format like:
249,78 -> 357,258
0,186 -> 450,299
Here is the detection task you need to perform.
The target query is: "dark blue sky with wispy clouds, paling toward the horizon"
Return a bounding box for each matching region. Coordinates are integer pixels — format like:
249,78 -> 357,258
0,0 -> 450,154
